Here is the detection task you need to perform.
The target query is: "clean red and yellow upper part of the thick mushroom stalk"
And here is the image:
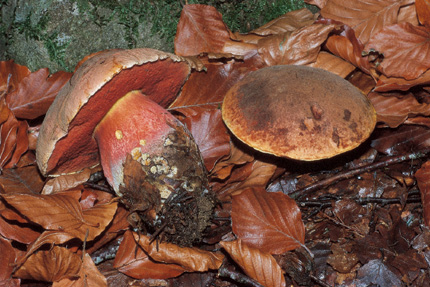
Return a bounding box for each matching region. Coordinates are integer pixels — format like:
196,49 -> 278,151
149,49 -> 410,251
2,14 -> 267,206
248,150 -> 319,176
94,91 -> 180,191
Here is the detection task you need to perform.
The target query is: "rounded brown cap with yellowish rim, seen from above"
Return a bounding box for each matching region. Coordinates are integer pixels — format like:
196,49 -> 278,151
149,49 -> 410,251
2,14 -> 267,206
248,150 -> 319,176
222,65 -> 376,161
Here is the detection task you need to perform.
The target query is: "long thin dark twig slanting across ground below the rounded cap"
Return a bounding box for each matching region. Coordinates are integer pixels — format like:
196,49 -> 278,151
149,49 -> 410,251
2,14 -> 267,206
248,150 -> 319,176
289,150 -> 430,200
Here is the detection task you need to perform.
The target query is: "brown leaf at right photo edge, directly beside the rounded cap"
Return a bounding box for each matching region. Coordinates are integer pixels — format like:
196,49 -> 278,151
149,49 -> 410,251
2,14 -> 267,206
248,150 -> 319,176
368,92 -> 430,128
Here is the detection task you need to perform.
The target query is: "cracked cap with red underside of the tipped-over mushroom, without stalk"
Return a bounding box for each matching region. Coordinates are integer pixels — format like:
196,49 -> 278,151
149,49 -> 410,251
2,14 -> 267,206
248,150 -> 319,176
36,48 -> 191,176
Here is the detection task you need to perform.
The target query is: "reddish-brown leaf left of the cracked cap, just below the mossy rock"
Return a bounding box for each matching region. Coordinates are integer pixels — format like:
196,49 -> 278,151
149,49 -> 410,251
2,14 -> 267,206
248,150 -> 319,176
6,68 -> 72,119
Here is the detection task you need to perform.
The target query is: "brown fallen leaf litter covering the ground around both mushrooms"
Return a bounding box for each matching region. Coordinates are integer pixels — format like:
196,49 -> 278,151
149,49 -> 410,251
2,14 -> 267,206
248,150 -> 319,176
0,0 -> 430,286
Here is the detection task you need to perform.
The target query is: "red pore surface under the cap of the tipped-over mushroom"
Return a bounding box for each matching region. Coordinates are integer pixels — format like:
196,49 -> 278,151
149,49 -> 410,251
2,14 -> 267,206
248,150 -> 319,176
42,58 -> 189,174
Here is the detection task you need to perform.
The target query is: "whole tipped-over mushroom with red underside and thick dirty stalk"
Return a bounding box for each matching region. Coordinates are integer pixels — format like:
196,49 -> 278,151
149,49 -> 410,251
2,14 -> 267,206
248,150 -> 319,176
36,49 -> 214,245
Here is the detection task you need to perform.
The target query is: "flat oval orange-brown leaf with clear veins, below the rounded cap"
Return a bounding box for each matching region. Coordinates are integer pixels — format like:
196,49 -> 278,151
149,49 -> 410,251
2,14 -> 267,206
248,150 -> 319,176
231,188 -> 305,254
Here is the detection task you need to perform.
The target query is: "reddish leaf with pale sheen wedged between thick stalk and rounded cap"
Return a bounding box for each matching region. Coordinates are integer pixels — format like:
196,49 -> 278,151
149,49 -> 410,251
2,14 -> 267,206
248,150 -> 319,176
175,105 -> 230,171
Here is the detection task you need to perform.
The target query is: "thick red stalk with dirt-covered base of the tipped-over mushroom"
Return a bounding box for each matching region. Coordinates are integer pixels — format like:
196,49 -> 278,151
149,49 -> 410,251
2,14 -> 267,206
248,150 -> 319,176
94,91 -> 214,245
